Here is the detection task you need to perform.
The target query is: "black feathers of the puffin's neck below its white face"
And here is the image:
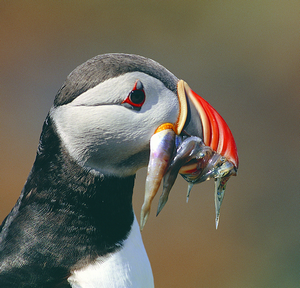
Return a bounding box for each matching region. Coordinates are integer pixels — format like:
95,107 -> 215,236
0,117 -> 134,287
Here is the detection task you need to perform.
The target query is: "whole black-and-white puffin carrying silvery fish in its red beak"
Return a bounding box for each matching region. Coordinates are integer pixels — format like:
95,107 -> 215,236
0,53 -> 238,288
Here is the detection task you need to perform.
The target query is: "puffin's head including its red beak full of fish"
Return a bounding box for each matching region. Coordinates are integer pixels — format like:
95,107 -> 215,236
50,54 -> 238,229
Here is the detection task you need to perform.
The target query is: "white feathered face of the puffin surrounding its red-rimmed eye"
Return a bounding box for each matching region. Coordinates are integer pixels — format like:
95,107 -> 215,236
50,72 -> 179,176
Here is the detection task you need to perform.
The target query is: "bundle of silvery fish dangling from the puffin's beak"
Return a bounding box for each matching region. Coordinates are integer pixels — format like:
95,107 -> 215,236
140,124 -> 237,230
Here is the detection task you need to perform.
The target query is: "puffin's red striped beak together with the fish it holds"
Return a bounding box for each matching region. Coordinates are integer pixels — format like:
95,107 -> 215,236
140,80 -> 239,230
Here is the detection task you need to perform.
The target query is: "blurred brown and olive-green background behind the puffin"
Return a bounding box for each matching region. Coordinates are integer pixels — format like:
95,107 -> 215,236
0,0 -> 300,288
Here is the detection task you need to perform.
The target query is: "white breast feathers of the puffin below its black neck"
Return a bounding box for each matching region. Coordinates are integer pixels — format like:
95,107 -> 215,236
68,218 -> 154,288
